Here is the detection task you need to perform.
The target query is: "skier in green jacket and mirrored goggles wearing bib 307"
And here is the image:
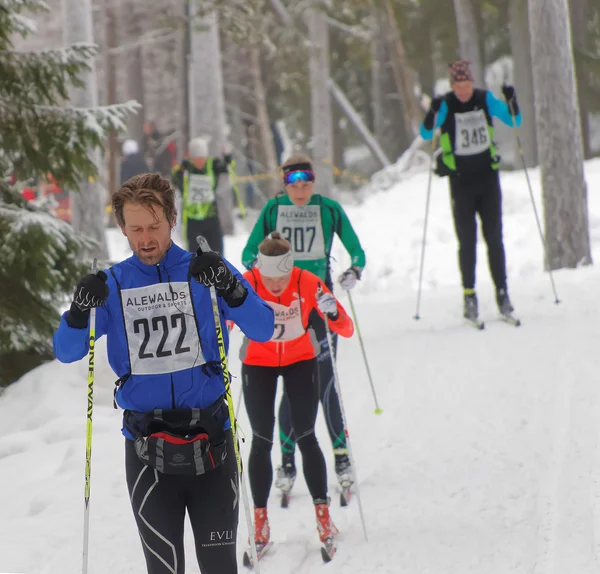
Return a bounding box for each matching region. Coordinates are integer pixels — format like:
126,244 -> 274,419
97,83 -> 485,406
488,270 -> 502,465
242,155 -> 366,498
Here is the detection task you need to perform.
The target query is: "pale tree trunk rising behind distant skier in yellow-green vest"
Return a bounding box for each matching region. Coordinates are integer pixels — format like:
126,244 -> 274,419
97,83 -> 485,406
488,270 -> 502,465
191,11 -> 233,234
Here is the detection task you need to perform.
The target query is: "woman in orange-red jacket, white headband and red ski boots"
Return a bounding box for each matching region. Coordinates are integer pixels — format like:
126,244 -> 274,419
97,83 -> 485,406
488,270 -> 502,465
240,232 -> 354,556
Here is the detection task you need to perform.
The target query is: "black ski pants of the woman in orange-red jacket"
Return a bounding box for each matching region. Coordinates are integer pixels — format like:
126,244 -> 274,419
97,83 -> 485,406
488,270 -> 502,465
242,359 -> 327,508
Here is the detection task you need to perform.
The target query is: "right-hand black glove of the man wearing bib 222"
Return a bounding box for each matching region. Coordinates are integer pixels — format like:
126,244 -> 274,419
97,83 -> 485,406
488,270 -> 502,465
190,249 -> 248,307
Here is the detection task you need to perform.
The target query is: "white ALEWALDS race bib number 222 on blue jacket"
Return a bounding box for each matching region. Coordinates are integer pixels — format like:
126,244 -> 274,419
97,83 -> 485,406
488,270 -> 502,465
121,282 -> 204,375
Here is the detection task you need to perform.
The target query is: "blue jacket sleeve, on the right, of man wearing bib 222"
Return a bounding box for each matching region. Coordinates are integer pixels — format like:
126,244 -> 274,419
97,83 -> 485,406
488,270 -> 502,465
222,262 -> 275,343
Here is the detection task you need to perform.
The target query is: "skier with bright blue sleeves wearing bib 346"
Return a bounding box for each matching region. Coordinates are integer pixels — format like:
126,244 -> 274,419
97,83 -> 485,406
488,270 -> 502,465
420,60 -> 521,321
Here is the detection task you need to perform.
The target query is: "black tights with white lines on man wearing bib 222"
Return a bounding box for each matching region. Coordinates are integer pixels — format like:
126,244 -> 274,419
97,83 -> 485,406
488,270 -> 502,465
125,431 -> 240,574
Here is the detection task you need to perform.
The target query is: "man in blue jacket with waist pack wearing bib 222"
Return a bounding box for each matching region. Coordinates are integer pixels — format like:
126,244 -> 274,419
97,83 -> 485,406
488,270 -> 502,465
54,174 -> 274,574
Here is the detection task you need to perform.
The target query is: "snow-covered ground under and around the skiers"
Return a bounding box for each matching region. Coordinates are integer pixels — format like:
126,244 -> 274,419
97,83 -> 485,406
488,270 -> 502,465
0,160 -> 600,574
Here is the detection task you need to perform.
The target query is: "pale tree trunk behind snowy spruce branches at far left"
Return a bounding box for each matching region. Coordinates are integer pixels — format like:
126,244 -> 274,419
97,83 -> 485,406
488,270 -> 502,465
62,0 -> 108,261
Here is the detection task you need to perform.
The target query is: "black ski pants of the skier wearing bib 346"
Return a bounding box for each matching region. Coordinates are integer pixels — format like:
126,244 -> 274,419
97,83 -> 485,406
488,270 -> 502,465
450,170 -> 506,289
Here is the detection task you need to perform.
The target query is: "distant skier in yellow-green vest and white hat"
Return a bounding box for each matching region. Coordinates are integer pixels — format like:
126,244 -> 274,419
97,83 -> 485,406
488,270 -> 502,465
172,137 -> 231,254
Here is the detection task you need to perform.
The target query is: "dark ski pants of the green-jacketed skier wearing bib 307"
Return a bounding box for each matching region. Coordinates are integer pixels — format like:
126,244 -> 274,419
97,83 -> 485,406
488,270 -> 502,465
279,311 -> 347,462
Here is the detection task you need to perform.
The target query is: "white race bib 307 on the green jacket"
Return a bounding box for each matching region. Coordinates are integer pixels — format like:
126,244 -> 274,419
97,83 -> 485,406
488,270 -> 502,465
277,205 -> 325,261
